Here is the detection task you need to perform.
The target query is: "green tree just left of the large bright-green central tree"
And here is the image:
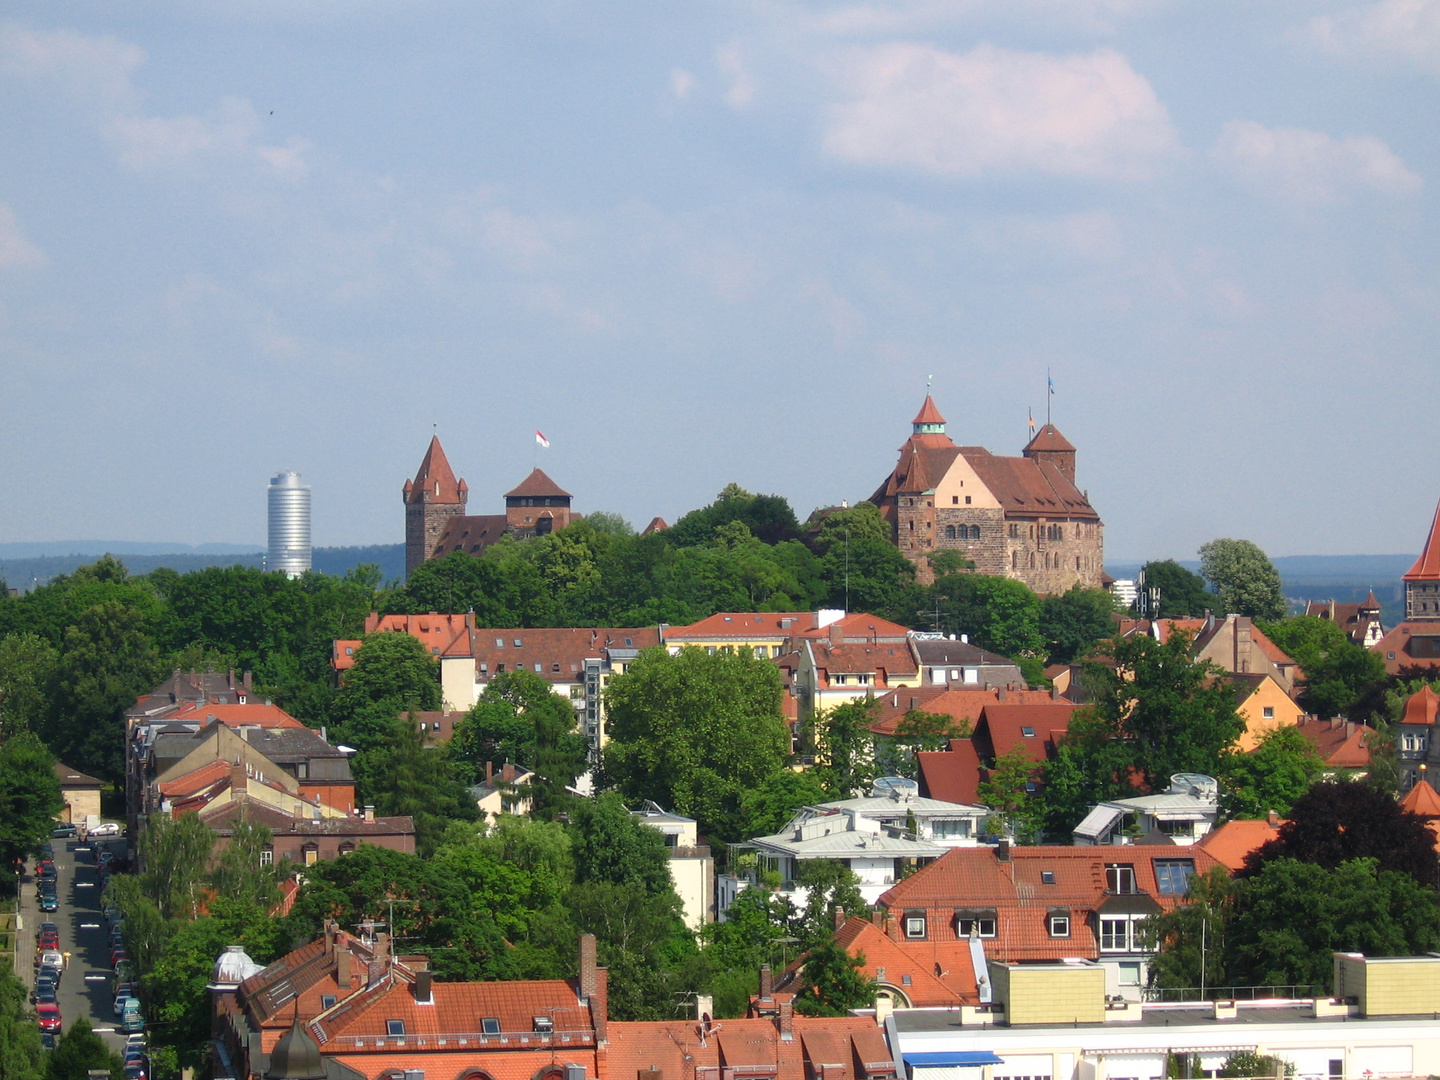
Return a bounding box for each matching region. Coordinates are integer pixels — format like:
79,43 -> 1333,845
451,671 -> 588,818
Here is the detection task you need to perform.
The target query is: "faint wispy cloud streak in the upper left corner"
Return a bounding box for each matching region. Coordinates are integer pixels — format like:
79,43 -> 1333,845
0,23 -> 310,180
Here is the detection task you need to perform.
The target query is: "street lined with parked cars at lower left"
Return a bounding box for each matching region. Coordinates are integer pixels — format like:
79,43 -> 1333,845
16,840 -> 125,1051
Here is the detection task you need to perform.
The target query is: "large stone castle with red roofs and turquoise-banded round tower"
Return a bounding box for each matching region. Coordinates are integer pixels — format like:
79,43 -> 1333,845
870,395 -> 1107,593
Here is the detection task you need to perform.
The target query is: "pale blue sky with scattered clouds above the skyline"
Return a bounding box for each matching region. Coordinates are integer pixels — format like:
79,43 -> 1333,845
0,0 -> 1440,562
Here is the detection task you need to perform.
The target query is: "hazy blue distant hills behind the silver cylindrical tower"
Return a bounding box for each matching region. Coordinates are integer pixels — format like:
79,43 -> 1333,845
0,544 -> 405,590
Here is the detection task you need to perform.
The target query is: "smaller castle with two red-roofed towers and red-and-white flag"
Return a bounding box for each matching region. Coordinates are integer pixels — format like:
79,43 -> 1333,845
402,436 -> 580,577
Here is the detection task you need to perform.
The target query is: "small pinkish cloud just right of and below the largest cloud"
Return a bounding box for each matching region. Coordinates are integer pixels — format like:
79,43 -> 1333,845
1211,120 -> 1421,209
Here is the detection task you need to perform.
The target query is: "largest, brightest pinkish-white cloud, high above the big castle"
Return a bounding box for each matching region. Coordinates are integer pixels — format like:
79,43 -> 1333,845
825,43 -> 1179,179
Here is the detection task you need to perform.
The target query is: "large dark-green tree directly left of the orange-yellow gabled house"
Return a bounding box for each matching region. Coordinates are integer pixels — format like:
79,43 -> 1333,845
1084,632 -> 1246,791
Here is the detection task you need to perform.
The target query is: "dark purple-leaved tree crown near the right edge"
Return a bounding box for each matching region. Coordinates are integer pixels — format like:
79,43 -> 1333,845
1241,780 -> 1440,890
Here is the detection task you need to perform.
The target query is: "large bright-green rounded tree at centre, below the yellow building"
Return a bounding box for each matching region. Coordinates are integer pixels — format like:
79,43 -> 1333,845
605,648 -> 791,841
